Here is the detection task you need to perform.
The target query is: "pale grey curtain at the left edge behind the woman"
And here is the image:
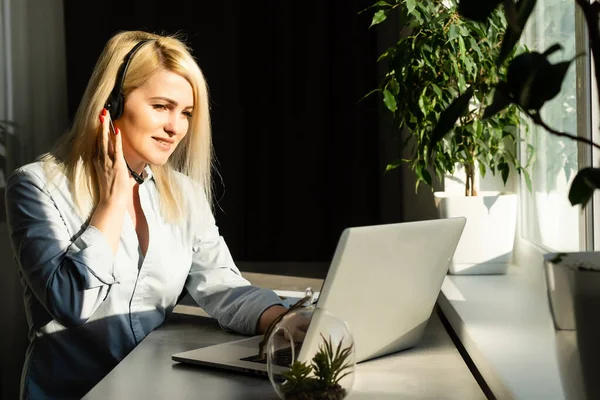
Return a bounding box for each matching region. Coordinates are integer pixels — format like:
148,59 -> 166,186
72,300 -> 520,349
0,0 -> 68,399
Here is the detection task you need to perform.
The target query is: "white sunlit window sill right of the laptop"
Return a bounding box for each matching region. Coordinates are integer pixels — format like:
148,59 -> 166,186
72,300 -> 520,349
438,252 -> 565,399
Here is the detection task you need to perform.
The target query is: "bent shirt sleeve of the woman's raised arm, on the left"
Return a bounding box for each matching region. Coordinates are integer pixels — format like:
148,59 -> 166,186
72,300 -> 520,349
6,169 -> 118,326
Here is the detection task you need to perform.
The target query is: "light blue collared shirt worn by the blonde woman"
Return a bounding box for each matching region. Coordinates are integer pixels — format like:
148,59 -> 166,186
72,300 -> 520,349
6,162 -> 281,399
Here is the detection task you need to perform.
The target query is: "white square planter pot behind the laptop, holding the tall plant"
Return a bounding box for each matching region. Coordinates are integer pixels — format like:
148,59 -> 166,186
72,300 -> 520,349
434,192 -> 517,275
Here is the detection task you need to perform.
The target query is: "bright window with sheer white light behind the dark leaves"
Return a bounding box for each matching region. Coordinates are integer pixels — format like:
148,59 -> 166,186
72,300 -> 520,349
520,0 -> 591,251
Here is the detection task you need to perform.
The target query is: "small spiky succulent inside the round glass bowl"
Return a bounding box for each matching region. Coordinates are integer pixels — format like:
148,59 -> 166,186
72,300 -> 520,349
281,335 -> 354,400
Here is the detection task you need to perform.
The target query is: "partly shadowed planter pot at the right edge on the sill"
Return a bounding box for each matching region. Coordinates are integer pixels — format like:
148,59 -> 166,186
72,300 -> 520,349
544,252 -> 600,399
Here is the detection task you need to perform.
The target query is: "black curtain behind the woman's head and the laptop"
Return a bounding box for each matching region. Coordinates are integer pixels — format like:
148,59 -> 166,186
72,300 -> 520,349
65,0 -> 390,261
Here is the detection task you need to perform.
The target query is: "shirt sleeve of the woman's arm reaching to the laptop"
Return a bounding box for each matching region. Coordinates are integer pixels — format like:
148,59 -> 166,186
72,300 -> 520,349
186,184 -> 283,334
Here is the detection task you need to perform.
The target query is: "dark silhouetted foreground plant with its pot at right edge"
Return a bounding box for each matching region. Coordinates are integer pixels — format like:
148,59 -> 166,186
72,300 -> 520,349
378,0 -> 600,399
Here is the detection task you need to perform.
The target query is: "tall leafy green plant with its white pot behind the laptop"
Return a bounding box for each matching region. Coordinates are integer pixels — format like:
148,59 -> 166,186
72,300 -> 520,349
372,0 -> 529,274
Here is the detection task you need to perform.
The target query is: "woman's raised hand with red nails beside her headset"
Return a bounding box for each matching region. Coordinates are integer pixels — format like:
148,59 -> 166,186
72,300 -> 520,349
90,109 -> 133,254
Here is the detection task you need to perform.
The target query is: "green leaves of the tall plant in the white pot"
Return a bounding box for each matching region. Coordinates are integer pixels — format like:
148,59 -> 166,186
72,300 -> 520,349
372,0 -> 524,195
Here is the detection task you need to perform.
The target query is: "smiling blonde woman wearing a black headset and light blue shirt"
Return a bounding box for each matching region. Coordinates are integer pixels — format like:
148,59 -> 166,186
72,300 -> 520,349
6,31 -> 287,399
